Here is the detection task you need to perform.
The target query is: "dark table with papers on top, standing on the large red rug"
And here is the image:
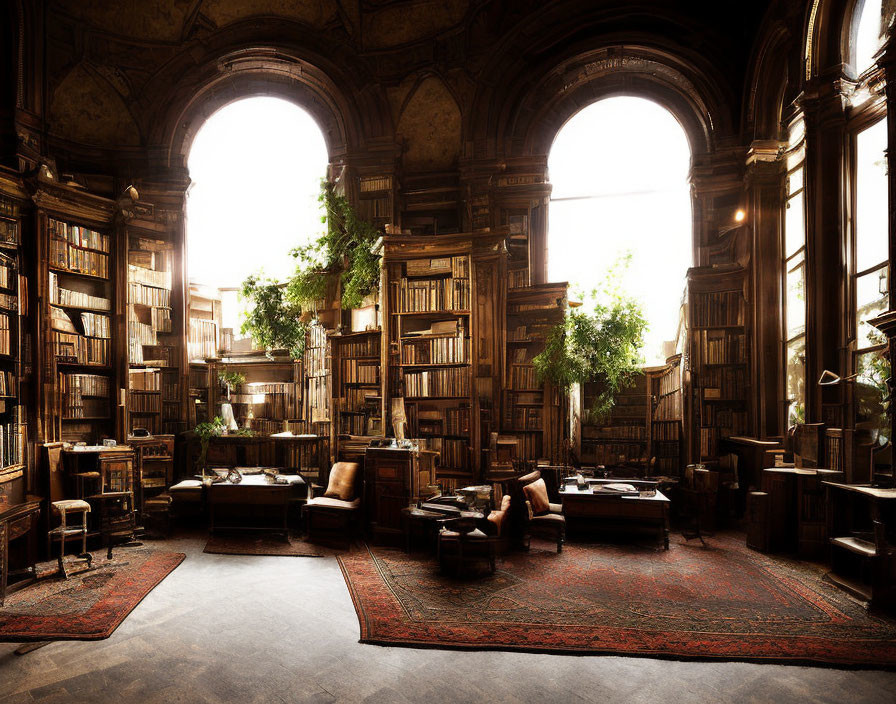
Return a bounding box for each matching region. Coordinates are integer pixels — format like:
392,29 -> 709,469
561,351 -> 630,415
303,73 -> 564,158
560,479 -> 669,550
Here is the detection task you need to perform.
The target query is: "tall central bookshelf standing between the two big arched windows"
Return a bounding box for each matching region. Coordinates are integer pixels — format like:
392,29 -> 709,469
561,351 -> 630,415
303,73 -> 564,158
381,231 -> 506,481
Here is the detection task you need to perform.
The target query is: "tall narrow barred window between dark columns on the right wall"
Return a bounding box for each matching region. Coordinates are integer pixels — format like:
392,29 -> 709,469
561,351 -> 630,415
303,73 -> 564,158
782,116 -> 806,425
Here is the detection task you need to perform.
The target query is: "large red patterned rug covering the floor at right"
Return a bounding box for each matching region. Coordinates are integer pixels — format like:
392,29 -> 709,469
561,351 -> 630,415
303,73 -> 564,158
339,536 -> 896,667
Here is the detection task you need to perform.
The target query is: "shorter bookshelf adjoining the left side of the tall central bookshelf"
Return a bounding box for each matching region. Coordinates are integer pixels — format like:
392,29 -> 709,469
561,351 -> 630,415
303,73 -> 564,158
330,330 -> 383,440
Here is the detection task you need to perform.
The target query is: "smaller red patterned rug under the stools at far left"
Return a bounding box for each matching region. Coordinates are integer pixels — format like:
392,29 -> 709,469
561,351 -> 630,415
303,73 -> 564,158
0,547 -> 185,642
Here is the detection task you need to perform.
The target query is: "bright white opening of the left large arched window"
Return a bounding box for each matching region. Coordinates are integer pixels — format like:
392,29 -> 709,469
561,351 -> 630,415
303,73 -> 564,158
187,97 -> 327,350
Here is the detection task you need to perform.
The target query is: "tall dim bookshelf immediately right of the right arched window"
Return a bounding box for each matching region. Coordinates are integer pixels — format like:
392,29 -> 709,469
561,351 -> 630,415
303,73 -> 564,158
688,266 -> 750,462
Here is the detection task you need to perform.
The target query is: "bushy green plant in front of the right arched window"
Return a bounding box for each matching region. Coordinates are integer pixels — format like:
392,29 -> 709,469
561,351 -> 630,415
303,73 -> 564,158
534,255 -> 647,415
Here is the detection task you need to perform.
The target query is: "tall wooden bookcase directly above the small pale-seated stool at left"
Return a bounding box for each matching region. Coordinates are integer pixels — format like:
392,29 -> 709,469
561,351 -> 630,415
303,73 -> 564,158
38,201 -> 119,444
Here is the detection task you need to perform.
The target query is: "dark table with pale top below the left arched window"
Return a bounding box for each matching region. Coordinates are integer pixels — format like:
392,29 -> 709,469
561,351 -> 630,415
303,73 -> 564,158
208,474 -> 307,534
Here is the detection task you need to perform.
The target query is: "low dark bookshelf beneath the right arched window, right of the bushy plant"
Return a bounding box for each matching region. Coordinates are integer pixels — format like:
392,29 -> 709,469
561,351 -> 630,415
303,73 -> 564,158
578,373 -> 649,470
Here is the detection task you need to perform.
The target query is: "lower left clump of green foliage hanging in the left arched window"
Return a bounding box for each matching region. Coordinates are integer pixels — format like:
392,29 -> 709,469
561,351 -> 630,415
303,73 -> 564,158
240,274 -> 308,359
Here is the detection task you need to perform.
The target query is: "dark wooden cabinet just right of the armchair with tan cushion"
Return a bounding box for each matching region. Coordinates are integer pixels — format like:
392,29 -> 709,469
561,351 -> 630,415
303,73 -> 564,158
364,447 -> 433,544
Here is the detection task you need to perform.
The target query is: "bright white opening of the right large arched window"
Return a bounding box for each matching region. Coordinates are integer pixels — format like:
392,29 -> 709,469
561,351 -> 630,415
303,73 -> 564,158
548,97 -> 693,363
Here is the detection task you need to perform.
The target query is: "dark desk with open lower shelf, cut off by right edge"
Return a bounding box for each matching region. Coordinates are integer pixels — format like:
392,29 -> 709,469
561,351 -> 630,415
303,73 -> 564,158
824,482 -> 896,608
